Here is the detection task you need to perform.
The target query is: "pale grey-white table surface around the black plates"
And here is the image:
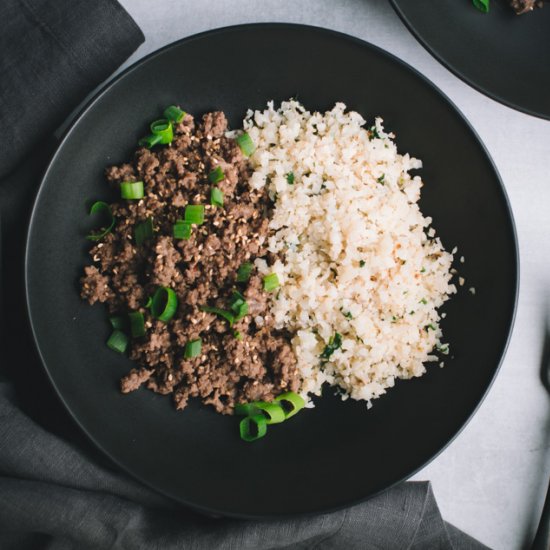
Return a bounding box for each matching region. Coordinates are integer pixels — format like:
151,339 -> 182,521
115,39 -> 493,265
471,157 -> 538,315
110,0 -> 550,549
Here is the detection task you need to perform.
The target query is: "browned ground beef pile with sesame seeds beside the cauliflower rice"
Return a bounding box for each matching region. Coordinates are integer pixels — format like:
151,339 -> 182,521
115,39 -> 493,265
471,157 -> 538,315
81,112 -> 298,414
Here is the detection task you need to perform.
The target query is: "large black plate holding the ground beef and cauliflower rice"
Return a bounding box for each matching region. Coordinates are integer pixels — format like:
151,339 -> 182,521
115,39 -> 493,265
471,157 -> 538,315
26,24 -> 517,518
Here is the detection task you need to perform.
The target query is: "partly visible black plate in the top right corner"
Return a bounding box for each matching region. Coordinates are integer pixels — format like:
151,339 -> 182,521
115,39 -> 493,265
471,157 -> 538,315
391,0 -> 550,119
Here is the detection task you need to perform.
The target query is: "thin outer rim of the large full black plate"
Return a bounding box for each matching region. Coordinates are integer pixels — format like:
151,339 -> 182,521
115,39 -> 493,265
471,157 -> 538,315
24,22 -> 520,520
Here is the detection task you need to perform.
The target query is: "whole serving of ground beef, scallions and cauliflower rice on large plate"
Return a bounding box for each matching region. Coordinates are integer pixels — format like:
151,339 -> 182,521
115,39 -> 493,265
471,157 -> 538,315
81,100 -> 462,441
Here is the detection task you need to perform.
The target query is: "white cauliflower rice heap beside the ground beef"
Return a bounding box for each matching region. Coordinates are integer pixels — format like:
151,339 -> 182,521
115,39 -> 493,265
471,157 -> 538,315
244,100 -> 456,406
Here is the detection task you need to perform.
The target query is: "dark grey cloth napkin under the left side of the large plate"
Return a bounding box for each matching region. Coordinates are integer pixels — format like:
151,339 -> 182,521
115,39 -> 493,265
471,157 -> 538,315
0,0 -> 492,550
